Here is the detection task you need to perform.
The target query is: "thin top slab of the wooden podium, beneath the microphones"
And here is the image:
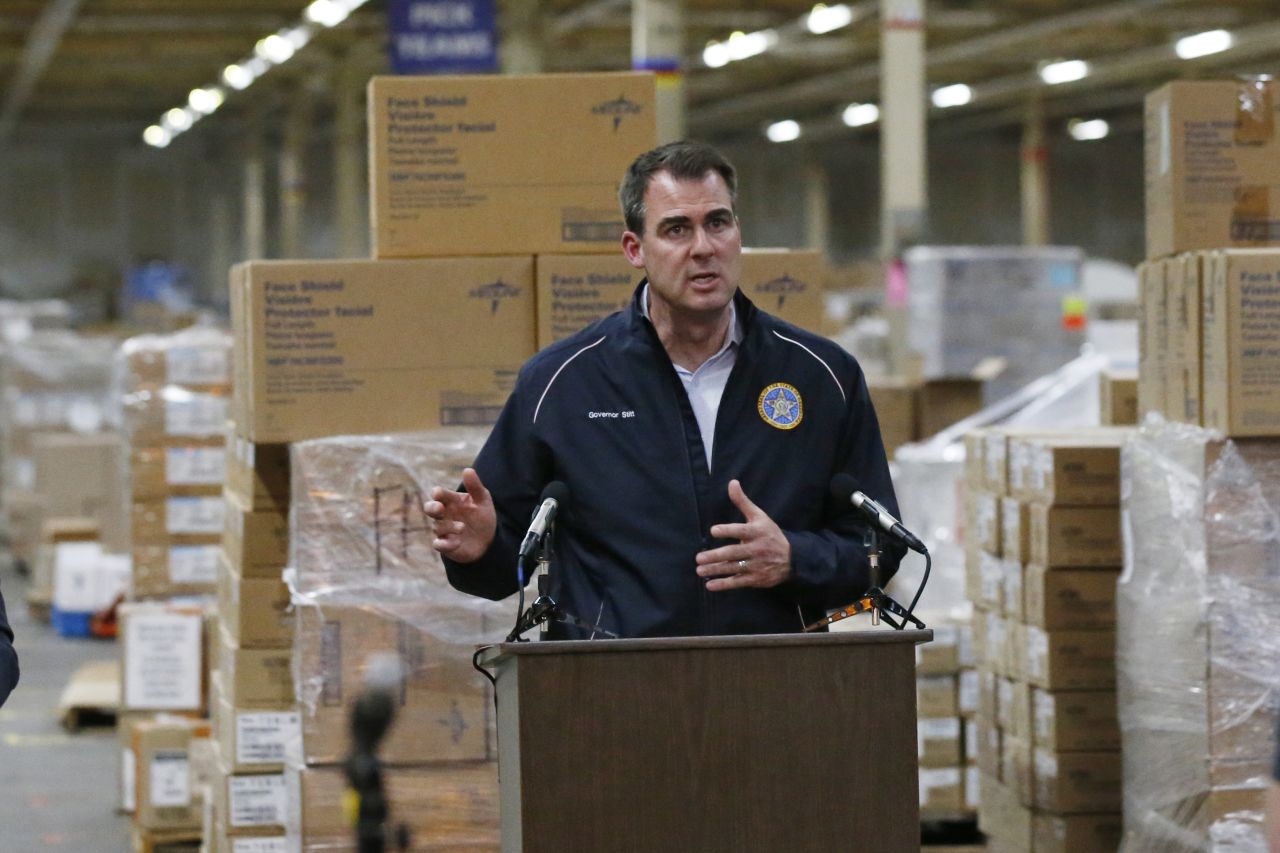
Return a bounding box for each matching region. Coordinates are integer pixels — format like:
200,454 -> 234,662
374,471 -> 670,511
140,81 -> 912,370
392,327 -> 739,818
480,629 -> 933,662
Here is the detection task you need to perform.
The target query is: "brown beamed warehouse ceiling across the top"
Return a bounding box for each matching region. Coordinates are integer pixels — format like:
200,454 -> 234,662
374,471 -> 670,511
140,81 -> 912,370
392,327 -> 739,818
0,0 -> 1280,145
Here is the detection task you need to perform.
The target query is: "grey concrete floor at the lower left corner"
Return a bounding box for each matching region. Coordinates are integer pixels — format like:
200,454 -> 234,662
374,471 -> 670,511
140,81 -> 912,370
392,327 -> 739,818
0,560 -> 129,853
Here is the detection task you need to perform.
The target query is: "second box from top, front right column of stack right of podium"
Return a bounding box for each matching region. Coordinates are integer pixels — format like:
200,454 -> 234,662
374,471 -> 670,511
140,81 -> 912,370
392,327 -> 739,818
1028,503 -> 1124,569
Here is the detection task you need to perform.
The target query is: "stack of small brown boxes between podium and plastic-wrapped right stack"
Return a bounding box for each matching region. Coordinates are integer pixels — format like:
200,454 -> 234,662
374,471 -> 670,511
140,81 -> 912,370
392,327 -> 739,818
965,428 -> 1130,852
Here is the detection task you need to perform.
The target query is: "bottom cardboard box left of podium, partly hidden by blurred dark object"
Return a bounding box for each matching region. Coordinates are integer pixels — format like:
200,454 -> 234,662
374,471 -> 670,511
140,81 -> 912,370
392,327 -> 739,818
297,762 -> 499,850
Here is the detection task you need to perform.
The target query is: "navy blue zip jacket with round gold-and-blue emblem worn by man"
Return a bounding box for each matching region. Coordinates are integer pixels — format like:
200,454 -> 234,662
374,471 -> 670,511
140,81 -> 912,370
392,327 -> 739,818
444,282 -> 904,639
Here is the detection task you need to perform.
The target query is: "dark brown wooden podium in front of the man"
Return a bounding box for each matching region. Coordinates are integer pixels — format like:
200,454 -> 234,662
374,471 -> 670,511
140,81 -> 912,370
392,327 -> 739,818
483,630 -> 933,853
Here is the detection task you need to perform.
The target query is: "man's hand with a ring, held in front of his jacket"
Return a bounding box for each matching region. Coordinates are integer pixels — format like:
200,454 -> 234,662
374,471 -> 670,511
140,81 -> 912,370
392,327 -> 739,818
698,480 -> 791,592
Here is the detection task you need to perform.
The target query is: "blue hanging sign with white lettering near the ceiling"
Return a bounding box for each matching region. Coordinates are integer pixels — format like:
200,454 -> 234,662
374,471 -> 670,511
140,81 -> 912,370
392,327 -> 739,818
387,0 -> 498,74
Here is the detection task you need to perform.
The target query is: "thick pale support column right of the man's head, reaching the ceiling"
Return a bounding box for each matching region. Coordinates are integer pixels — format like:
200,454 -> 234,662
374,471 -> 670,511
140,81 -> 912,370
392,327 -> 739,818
881,0 -> 928,259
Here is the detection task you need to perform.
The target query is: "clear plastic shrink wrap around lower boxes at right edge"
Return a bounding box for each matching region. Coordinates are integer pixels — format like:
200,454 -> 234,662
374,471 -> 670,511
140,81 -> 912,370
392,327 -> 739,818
1116,415 -> 1280,853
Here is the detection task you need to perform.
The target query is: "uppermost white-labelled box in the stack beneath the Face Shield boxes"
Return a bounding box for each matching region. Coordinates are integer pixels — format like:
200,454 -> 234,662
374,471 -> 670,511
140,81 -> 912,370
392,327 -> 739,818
209,672 -> 302,774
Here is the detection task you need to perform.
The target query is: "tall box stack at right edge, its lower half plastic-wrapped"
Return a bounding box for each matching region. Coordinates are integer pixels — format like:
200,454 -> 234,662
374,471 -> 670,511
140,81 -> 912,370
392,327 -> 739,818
1119,78 -> 1280,850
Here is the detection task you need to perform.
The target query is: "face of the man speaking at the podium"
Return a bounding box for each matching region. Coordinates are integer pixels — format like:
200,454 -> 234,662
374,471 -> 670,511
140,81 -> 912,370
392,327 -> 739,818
622,170 -> 742,316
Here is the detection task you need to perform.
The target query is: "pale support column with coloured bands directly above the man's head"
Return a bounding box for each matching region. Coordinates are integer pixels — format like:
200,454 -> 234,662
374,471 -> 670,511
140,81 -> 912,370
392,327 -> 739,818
631,0 -> 686,142
